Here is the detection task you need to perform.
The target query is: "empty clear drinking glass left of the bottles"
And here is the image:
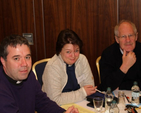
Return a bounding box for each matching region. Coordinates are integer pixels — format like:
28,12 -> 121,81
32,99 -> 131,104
93,97 -> 103,113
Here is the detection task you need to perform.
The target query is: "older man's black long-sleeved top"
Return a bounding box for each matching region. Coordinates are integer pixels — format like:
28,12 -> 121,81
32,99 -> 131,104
98,42 -> 141,91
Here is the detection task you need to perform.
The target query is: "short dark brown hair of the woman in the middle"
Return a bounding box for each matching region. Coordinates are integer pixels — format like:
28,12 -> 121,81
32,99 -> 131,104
56,29 -> 83,55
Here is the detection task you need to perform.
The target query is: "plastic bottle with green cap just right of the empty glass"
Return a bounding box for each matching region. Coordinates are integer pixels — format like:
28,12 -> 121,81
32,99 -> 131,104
105,87 -> 114,113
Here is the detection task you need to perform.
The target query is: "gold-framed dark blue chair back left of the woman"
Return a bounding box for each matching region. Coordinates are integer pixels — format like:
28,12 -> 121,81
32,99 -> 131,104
32,58 -> 50,86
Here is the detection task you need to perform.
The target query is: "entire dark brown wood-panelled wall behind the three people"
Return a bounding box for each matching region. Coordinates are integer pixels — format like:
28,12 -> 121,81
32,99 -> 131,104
0,0 -> 141,85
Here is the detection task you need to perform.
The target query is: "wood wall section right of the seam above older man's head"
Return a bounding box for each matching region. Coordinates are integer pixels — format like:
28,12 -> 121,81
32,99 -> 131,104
119,0 -> 141,42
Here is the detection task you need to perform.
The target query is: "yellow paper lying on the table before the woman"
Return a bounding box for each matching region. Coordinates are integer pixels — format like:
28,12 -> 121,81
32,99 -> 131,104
61,104 -> 95,113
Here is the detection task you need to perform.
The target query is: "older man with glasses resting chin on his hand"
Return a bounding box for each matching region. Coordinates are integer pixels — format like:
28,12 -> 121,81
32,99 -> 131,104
98,20 -> 141,90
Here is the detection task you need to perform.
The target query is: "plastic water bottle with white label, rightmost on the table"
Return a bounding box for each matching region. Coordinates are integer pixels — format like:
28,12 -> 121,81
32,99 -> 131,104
131,81 -> 140,105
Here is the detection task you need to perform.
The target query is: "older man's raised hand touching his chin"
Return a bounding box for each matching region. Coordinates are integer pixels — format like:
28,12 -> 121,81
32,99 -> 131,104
120,50 -> 136,74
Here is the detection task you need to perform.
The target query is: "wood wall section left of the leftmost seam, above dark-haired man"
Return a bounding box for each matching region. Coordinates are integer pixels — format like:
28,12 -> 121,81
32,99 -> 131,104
0,0 -> 35,61
